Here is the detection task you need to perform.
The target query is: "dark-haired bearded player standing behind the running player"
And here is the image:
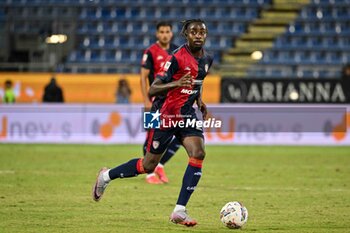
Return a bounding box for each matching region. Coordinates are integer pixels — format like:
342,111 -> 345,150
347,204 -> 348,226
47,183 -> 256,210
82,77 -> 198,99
141,21 -> 181,184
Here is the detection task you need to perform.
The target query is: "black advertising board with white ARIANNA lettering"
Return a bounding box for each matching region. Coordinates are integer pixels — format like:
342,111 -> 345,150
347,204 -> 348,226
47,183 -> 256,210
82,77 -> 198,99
221,78 -> 350,104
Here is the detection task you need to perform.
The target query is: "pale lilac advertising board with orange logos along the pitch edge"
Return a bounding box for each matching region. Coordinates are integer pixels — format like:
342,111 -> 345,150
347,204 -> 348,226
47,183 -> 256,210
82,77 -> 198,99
0,104 -> 350,145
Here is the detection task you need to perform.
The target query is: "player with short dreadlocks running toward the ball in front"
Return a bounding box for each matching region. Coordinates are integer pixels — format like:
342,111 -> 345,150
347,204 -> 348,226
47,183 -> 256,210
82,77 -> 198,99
93,19 -> 213,226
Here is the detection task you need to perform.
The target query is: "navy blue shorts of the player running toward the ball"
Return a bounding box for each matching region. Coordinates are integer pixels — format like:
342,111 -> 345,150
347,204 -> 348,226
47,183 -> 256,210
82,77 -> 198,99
145,128 -> 204,154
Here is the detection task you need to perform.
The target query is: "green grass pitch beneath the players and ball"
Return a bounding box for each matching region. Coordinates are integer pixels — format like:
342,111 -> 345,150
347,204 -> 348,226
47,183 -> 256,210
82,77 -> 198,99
0,144 -> 350,233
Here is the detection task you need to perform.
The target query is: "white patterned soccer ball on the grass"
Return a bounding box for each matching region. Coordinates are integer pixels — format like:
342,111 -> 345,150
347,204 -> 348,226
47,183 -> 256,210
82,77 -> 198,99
220,201 -> 248,229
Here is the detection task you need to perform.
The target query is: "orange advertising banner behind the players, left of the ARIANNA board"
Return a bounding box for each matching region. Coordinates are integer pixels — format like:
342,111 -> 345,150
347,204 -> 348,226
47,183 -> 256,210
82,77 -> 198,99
0,73 -> 220,103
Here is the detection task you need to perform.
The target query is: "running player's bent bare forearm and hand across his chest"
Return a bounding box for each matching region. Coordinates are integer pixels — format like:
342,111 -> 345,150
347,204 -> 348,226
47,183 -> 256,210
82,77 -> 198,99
148,73 -> 193,97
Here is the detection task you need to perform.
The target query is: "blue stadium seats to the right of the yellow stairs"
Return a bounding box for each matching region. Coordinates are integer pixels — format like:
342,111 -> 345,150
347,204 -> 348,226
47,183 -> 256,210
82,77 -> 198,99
248,0 -> 350,78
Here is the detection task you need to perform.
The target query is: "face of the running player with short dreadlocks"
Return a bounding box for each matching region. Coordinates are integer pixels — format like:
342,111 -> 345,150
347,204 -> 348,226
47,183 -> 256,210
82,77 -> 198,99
186,23 -> 207,49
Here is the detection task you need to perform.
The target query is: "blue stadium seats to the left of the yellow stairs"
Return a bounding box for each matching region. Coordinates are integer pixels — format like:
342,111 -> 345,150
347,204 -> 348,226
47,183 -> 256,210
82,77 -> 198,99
0,0 -> 271,72
